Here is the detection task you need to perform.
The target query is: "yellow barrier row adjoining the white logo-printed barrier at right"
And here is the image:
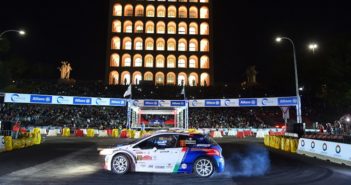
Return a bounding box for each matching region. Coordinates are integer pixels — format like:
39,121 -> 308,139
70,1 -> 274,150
264,135 -> 298,153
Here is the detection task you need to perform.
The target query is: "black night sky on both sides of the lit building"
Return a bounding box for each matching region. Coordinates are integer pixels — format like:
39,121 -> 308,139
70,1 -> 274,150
0,0 -> 351,84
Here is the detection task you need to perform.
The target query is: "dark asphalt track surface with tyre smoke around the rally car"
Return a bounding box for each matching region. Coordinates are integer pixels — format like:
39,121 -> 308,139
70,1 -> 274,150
0,138 -> 351,185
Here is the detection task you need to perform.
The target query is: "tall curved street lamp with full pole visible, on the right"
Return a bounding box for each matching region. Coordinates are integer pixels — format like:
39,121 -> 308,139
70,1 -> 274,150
275,37 -> 302,123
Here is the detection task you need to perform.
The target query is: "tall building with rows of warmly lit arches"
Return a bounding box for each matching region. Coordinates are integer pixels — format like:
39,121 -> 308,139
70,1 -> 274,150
106,0 -> 213,86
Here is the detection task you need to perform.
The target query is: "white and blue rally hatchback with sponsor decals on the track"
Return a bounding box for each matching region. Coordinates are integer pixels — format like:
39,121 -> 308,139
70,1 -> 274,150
100,132 -> 224,177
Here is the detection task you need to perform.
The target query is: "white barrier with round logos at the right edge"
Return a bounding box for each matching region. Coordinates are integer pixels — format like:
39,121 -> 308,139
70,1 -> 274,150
297,138 -> 351,166
